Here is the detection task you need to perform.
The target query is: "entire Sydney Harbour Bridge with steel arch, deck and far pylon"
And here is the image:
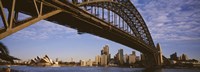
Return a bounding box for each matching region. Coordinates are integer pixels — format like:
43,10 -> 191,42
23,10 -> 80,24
0,0 -> 166,67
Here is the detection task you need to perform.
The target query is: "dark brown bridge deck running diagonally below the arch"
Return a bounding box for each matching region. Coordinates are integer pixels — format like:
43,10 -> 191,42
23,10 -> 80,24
2,0 -> 157,53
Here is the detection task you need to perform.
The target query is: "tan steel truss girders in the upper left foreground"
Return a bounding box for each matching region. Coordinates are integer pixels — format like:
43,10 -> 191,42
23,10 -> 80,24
0,0 -> 62,39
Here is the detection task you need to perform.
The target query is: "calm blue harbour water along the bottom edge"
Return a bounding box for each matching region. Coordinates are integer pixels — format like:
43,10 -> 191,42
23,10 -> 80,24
0,66 -> 200,72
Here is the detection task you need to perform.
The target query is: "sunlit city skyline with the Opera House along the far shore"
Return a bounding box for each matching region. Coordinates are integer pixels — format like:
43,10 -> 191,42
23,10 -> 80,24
16,45 -> 196,62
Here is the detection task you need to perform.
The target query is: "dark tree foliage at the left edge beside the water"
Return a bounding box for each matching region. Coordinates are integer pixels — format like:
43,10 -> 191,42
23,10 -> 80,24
0,42 -> 20,63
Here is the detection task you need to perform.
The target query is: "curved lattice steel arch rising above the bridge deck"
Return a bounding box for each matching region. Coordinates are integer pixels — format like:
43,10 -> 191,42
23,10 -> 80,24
73,0 -> 155,48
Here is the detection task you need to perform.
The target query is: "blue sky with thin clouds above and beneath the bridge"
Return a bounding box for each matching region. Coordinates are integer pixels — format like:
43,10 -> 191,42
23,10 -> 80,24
0,0 -> 200,61
